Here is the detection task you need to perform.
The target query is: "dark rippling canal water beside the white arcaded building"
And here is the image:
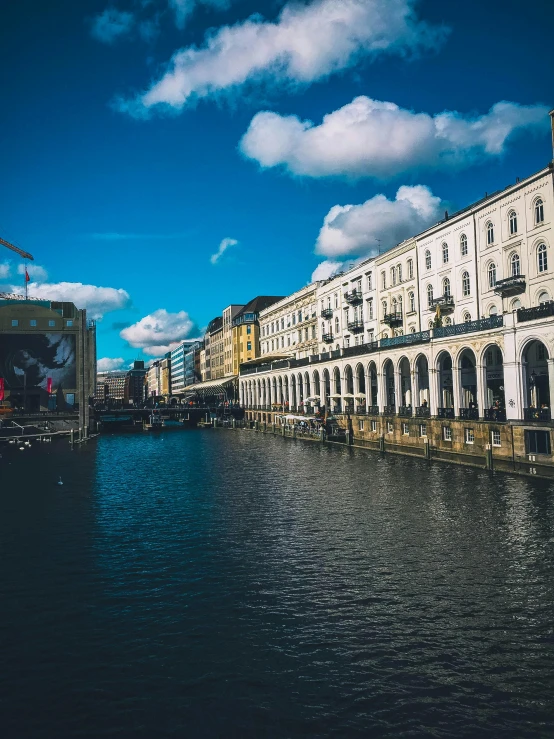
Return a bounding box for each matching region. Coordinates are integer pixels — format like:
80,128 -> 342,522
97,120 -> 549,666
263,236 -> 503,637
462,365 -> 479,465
0,430 -> 554,739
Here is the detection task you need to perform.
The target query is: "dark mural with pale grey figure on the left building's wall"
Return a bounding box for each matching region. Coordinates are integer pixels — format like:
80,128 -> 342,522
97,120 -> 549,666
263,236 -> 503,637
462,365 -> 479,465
0,333 -> 77,391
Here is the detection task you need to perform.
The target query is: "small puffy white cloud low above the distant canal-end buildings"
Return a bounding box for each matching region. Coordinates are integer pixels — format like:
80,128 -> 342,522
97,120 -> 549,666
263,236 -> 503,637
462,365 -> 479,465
119,308 -> 196,356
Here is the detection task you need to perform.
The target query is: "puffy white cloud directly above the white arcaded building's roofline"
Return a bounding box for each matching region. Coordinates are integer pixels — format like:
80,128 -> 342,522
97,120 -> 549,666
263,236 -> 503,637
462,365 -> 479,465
316,185 -> 441,260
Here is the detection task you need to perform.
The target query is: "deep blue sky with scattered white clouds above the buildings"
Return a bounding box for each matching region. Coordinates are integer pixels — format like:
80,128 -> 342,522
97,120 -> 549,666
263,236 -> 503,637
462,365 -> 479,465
0,0 -> 554,367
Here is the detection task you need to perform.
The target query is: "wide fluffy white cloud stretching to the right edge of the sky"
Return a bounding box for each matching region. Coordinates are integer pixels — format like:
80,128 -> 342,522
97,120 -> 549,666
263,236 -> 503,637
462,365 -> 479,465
240,96 -> 549,179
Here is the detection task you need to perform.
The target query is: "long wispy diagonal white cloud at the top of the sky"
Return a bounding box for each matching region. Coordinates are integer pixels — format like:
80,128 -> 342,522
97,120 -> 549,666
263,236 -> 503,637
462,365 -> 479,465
115,0 -> 445,116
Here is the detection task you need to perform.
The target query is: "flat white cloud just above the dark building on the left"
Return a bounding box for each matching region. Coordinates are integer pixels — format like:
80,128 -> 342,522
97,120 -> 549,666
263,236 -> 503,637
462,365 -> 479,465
14,282 -> 131,319
